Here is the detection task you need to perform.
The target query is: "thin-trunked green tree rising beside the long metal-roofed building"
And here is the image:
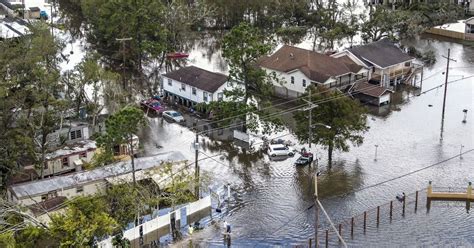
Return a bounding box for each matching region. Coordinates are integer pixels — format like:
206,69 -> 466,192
97,106 -> 146,185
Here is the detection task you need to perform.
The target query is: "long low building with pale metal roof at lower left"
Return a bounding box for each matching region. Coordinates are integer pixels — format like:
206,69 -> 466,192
7,152 -> 185,206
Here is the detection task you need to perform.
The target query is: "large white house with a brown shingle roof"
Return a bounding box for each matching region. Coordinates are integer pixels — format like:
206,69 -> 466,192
259,45 -> 368,98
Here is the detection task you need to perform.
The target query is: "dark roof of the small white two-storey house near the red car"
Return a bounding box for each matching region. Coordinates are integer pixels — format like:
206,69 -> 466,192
163,66 -> 228,93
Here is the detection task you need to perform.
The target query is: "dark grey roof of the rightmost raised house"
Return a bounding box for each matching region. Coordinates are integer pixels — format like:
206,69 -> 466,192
347,39 -> 414,68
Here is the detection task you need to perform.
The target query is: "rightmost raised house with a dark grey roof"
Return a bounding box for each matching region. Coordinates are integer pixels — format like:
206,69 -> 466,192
331,39 -> 415,88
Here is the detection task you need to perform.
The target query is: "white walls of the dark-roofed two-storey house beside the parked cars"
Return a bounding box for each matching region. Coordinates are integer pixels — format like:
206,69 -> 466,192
163,77 -> 235,103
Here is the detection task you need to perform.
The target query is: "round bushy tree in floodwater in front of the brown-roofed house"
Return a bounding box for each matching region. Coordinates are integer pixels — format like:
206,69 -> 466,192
294,86 -> 369,165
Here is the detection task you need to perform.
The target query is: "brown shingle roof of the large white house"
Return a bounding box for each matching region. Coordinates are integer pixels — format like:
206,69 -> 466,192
259,45 -> 362,83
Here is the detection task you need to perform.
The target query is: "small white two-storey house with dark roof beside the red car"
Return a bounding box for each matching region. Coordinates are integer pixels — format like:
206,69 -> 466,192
163,66 -> 235,106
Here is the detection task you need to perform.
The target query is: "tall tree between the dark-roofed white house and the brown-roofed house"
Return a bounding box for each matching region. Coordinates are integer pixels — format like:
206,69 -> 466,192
211,22 -> 278,132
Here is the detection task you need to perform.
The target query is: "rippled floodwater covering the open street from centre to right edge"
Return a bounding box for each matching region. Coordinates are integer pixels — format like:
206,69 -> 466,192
136,37 -> 474,247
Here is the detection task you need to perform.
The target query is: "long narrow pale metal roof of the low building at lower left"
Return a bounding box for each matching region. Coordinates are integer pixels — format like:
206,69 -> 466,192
9,152 -> 186,198
